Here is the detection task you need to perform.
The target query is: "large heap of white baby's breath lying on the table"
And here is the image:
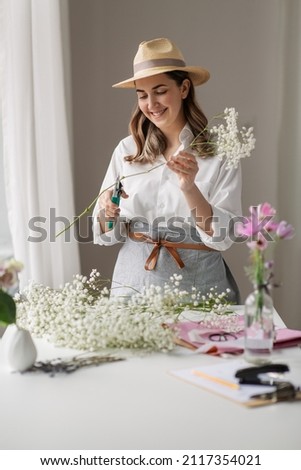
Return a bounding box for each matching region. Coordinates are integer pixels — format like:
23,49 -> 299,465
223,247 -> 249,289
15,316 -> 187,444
16,270 -> 233,351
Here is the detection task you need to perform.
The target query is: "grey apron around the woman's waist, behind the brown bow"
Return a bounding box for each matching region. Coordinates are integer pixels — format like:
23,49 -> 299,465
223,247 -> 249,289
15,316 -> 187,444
111,226 -> 240,304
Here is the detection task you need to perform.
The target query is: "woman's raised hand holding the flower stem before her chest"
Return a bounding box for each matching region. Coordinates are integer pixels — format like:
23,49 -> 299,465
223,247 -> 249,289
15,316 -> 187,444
167,151 -> 199,191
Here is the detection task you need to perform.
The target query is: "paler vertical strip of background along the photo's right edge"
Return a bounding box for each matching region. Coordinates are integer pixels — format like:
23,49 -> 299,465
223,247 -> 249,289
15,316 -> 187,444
274,0 -> 301,328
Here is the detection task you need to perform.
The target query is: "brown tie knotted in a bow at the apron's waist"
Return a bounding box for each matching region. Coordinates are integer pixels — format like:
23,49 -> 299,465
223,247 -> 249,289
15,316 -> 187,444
129,232 -> 215,271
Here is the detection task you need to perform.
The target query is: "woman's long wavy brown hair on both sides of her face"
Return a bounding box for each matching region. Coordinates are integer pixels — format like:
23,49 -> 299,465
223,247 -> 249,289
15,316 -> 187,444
125,70 -> 214,163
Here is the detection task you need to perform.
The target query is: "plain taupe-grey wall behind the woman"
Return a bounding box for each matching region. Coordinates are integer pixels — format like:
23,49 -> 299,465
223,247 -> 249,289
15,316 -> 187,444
69,0 -> 298,326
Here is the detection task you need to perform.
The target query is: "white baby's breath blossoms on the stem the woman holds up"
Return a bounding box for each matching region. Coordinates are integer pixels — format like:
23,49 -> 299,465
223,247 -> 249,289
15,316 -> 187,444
210,108 -> 256,169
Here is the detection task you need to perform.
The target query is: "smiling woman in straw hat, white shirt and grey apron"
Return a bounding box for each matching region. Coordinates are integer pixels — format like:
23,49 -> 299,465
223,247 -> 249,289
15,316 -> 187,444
93,38 -> 241,303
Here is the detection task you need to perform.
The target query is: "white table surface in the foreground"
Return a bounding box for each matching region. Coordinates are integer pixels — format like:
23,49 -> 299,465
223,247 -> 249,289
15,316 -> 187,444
0,306 -> 301,450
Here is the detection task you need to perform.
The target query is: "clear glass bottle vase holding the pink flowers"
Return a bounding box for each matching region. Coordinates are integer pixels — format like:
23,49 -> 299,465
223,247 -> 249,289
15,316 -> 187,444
244,288 -> 274,365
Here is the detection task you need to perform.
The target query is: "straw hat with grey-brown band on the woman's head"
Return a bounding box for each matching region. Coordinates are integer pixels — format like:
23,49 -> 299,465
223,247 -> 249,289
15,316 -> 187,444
113,38 -> 210,88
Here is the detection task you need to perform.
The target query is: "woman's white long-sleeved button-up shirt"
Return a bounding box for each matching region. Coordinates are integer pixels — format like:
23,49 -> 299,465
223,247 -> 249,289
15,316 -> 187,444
93,124 -> 241,251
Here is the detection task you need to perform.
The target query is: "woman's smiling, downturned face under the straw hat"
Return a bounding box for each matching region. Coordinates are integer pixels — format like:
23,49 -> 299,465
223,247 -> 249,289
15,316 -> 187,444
136,73 -> 190,133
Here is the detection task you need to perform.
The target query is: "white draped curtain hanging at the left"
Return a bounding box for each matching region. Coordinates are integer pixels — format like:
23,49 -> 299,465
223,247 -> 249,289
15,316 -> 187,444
0,0 -> 80,288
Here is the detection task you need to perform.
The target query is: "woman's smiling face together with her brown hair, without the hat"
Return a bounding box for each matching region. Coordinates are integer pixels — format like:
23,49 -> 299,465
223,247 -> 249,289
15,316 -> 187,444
128,70 -> 212,161
